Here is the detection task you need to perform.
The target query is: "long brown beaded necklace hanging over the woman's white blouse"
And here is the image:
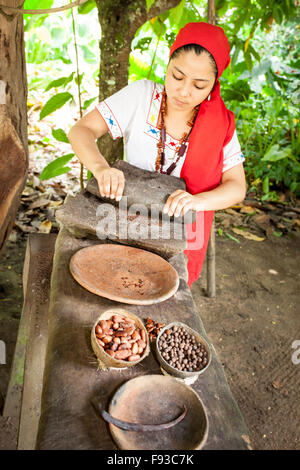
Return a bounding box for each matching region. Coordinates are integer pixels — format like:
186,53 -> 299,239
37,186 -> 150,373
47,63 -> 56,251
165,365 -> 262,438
155,89 -> 199,175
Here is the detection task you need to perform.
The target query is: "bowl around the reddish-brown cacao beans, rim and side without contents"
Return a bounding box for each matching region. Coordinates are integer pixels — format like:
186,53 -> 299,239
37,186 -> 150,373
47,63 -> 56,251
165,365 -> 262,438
91,308 -> 150,369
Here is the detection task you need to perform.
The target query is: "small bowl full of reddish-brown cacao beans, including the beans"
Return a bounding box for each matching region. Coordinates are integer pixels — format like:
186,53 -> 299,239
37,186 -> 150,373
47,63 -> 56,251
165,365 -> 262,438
91,308 -> 150,369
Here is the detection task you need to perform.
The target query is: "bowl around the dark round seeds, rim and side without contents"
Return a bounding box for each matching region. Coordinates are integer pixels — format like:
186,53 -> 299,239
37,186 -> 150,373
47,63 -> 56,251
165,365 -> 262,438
155,322 -> 211,379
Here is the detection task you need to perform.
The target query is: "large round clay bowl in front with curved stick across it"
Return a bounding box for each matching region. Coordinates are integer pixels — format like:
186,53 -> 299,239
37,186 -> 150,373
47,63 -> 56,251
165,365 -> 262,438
108,375 -> 208,450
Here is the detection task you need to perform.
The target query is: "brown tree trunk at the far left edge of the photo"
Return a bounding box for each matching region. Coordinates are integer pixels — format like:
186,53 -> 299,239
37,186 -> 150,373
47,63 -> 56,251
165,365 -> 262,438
0,0 -> 28,254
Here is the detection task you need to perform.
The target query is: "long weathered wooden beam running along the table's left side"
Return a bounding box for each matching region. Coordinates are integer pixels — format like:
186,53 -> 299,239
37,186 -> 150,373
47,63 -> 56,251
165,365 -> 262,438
3,233 -> 56,450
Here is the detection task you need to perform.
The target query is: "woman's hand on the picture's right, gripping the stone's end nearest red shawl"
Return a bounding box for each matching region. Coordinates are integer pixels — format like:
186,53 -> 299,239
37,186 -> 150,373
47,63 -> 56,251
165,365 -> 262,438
163,189 -> 205,217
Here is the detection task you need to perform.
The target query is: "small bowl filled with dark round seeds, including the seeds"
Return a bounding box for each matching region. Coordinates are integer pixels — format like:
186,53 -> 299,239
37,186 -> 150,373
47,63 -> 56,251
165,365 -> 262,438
156,322 -> 211,379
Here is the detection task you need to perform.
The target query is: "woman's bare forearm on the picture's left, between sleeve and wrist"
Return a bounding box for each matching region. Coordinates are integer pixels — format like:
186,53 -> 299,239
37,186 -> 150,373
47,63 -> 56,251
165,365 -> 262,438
68,125 -> 109,176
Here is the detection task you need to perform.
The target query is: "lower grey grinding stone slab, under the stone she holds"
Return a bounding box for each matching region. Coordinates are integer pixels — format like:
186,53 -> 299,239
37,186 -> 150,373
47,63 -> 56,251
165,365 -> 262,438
56,191 -> 187,258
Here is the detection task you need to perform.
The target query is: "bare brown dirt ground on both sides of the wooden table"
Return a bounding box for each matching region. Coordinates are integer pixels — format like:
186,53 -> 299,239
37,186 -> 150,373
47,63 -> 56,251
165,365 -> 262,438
0,231 -> 300,450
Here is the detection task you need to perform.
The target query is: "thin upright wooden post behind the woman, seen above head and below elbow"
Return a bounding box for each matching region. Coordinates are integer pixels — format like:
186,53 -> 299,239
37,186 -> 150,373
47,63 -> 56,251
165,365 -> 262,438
206,0 -> 216,297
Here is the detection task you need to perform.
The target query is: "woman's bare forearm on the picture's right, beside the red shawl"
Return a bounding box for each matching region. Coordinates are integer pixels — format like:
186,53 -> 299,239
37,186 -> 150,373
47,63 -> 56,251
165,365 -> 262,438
195,180 -> 246,211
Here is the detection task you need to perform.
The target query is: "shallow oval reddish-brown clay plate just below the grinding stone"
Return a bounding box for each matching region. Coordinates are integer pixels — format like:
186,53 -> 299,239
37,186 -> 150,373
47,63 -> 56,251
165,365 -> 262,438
70,244 -> 179,305
